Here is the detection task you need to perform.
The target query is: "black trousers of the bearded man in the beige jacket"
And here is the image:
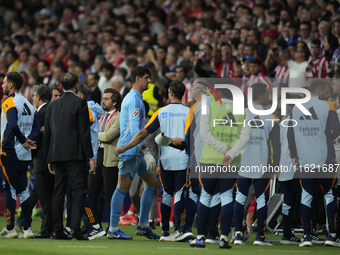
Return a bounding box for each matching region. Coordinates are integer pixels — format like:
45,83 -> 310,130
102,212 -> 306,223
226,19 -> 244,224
87,148 -> 118,223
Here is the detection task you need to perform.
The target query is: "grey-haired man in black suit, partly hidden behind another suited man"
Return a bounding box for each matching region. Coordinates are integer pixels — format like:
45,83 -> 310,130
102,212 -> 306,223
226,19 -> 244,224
32,85 -> 54,238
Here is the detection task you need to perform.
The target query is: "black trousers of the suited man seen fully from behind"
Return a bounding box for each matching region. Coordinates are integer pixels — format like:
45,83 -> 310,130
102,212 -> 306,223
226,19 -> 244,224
52,160 -> 87,232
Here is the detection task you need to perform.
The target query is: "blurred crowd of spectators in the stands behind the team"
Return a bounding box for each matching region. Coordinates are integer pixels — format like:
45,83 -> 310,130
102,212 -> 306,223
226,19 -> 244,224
0,0 -> 340,110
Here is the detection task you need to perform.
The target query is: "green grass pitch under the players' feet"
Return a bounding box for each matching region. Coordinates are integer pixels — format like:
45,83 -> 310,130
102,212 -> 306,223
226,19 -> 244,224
0,217 -> 340,255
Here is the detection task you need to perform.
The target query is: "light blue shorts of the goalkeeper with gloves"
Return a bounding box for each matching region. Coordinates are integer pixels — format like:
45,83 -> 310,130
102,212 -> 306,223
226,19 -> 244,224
118,156 -> 152,178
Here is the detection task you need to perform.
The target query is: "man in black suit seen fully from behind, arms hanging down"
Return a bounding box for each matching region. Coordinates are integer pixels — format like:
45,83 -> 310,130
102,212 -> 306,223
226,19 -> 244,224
44,73 -> 96,240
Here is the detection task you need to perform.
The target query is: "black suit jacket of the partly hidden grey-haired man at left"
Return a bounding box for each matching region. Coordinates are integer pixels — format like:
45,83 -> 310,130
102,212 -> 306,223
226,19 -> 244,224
32,104 -> 48,173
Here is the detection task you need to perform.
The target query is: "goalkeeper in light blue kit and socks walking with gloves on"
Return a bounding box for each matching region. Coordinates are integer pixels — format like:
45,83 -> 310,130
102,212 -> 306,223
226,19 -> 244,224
111,66 -> 159,240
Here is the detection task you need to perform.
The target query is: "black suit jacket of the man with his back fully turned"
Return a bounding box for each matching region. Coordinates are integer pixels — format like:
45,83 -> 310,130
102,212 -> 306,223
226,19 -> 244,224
44,92 -> 93,163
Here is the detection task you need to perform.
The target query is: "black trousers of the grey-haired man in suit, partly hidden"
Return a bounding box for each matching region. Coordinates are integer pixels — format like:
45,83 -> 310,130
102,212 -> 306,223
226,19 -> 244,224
35,171 -> 54,232
